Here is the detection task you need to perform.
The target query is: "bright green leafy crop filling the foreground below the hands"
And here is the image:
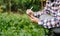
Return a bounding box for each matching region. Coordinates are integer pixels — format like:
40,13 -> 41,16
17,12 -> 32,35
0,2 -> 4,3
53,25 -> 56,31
0,13 -> 48,36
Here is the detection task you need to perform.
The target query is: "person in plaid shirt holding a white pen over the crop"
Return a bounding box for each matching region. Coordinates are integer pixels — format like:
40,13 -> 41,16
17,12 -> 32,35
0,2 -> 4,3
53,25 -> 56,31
26,0 -> 60,36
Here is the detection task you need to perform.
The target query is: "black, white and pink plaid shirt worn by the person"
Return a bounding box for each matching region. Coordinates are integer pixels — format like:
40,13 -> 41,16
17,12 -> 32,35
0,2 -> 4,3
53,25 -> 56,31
34,1 -> 60,28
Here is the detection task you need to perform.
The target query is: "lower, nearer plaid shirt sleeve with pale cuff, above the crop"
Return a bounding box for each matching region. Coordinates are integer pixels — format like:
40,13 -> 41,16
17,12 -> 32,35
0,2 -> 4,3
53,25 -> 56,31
38,17 -> 60,28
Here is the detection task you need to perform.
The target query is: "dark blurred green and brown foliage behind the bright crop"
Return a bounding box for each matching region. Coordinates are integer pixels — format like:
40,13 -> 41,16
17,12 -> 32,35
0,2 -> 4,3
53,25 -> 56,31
0,0 -> 43,12
